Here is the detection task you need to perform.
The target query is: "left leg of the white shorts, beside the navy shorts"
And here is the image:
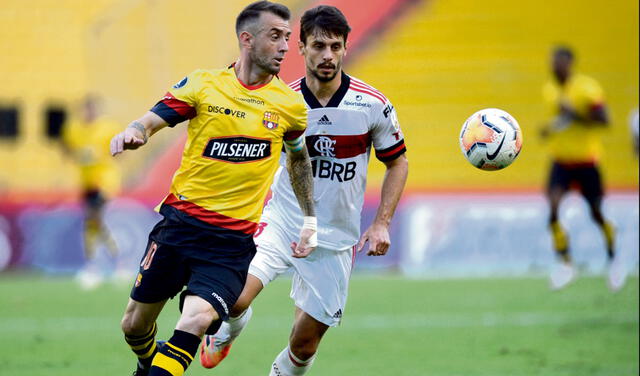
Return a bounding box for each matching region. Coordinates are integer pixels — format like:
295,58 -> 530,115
249,222 -> 295,287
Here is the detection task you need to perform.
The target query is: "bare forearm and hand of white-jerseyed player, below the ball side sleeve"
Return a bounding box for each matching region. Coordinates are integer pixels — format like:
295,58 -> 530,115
358,154 -> 409,256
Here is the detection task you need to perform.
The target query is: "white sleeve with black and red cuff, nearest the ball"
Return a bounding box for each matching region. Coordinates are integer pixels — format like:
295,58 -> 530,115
371,101 -> 407,162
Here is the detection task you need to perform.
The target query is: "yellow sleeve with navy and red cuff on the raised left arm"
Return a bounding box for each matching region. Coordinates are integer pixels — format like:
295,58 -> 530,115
151,70 -> 202,127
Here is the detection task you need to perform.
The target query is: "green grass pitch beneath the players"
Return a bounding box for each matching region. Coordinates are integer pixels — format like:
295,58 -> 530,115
0,273 -> 638,376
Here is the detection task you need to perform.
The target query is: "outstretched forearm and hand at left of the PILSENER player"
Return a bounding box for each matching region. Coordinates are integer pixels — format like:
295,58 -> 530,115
110,111 -> 168,156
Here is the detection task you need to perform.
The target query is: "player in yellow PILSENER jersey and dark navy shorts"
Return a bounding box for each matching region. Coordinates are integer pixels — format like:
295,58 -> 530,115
111,1 -> 317,376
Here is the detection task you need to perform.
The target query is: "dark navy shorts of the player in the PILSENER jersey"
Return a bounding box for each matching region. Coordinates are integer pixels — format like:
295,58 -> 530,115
131,205 -> 256,320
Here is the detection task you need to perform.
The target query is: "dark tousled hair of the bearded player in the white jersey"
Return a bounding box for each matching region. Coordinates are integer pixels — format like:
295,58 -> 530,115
300,5 -> 351,43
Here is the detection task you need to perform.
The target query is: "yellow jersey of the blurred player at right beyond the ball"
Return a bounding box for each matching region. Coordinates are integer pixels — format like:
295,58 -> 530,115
543,74 -> 605,164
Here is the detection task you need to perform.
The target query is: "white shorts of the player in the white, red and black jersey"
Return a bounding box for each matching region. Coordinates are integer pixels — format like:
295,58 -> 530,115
249,223 -> 355,326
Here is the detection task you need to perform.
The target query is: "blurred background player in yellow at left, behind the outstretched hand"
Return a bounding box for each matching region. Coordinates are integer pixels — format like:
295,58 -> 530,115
62,95 -> 120,288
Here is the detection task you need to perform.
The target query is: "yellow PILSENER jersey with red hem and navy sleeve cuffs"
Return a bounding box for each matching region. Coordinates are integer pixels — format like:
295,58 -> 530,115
151,66 -> 307,234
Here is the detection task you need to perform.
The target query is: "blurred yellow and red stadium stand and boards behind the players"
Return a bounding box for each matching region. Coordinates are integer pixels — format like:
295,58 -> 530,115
0,0 -> 638,274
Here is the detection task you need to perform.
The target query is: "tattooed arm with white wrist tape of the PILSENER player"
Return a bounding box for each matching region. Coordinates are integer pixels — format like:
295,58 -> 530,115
286,142 -> 318,258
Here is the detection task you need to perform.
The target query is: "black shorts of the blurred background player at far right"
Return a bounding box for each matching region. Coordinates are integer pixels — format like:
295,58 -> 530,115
548,162 -> 604,202
